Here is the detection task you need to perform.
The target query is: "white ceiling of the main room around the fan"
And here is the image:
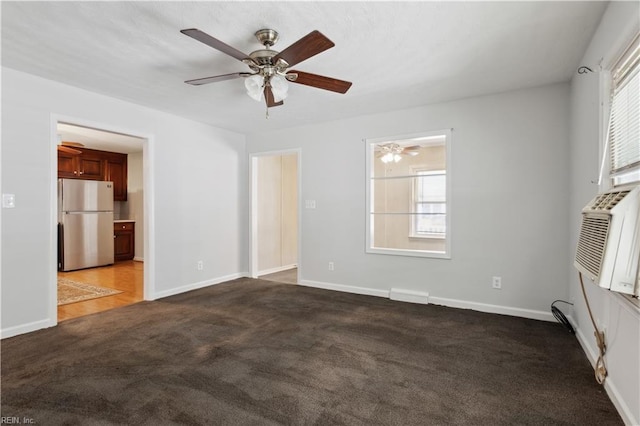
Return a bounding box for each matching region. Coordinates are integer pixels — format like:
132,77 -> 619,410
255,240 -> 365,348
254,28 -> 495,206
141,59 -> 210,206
1,1 -> 606,133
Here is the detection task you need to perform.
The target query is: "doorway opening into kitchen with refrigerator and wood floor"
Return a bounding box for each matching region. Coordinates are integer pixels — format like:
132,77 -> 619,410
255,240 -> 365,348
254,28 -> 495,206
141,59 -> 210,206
52,119 -> 149,322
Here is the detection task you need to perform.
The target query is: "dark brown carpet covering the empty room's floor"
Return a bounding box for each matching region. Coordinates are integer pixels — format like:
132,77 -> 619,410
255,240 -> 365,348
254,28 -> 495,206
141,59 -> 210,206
2,279 -> 622,426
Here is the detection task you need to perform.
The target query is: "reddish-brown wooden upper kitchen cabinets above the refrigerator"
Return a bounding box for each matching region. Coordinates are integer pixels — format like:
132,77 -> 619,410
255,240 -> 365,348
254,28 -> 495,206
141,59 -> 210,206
58,148 -> 127,201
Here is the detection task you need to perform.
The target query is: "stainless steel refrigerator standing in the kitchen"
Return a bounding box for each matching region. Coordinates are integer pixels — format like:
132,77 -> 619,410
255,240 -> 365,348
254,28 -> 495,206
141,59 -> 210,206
58,179 -> 114,271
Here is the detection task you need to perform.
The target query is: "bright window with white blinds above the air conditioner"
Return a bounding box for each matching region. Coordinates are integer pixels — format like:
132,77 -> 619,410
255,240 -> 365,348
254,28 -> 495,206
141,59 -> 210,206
607,35 -> 640,186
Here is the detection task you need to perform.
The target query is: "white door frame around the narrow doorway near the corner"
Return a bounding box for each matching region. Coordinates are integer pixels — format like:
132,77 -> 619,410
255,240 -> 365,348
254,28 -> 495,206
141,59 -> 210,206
249,148 -> 303,283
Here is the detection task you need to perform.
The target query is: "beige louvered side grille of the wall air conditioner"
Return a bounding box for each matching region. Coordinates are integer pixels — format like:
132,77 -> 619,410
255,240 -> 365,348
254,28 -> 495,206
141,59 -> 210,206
576,215 -> 608,277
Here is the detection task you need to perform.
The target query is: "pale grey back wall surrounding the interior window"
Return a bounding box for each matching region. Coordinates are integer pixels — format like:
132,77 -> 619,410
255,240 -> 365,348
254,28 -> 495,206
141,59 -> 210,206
247,84 -> 569,319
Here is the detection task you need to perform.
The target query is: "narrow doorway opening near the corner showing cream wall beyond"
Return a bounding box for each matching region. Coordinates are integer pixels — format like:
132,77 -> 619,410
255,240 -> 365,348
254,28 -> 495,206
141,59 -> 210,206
250,150 -> 300,284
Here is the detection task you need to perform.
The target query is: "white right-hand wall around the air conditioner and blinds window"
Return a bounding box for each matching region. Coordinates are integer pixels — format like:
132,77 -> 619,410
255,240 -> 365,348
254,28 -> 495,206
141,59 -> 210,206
567,2 -> 640,425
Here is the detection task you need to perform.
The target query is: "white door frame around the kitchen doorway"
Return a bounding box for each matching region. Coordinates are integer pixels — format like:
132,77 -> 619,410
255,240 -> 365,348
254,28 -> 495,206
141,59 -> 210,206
49,113 -> 155,325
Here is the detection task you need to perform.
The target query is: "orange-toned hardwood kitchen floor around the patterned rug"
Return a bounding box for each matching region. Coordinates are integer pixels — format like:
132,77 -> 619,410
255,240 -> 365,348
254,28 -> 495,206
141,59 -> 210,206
58,260 -> 144,322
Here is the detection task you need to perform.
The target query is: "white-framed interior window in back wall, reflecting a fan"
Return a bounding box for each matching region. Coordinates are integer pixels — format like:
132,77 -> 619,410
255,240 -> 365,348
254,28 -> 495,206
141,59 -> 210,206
366,130 -> 451,258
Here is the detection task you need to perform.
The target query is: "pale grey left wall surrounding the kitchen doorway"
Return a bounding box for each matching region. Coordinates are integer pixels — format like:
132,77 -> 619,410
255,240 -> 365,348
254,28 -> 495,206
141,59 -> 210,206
1,68 -> 248,337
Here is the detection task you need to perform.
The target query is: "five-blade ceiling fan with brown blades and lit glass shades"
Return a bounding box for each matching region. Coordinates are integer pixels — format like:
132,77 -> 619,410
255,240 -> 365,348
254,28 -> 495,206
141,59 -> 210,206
180,28 -> 351,109
